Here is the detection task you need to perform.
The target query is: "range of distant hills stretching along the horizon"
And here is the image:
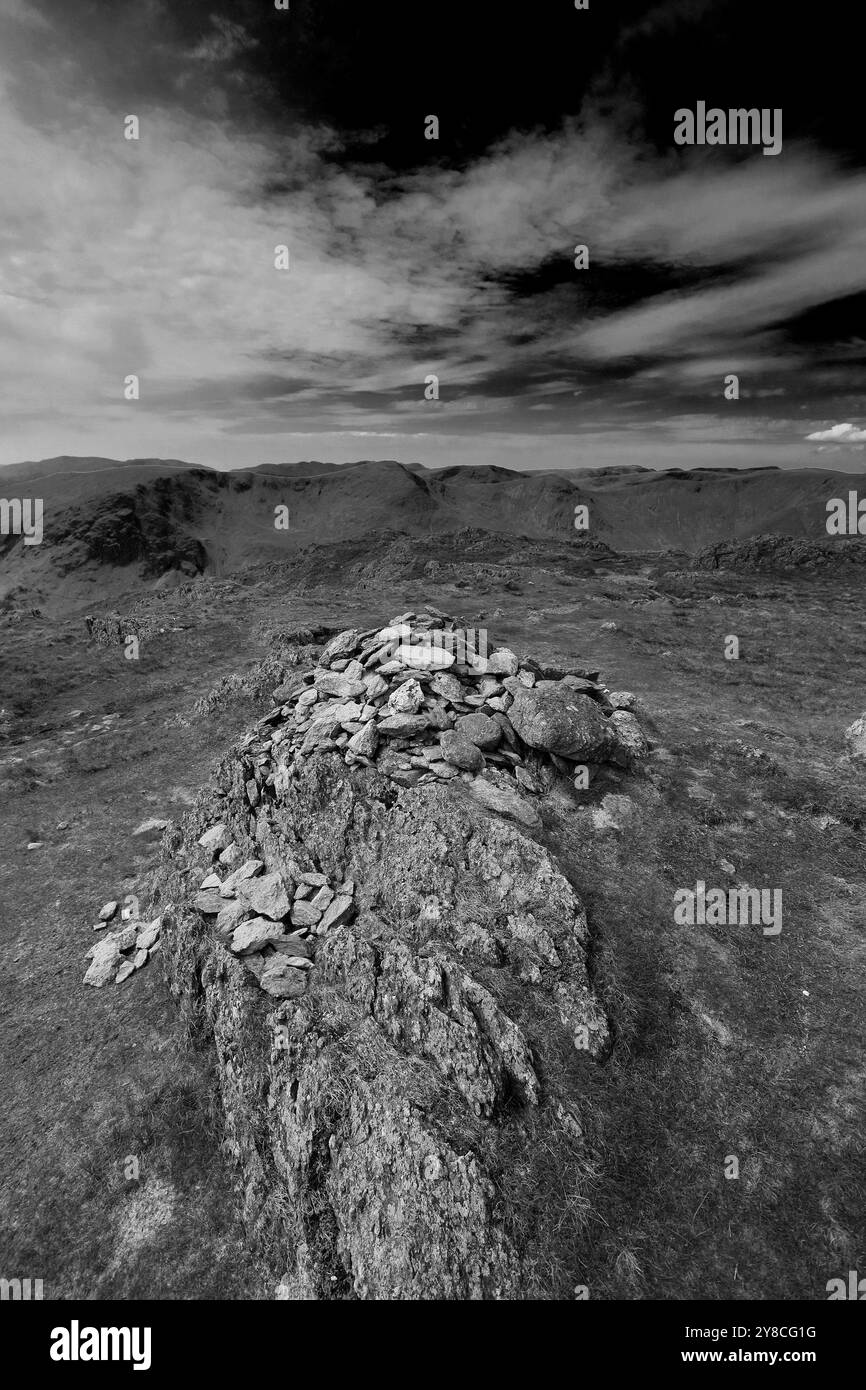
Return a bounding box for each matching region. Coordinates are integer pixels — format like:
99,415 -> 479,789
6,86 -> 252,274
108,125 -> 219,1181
0,457 -> 866,600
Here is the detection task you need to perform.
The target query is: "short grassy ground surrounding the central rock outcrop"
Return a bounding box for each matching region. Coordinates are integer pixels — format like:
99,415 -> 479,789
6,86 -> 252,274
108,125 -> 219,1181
0,549 -> 866,1298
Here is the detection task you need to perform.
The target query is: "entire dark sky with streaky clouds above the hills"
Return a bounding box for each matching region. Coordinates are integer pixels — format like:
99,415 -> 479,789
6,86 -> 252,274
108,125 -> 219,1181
0,0 -> 866,470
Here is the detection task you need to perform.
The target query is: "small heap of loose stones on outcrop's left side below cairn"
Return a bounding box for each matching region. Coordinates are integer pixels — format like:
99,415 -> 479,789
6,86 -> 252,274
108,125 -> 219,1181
193,821 -> 354,999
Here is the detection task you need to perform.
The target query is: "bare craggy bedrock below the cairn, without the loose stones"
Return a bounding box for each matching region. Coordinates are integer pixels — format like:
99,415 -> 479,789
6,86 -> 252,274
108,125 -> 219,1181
157,749 -> 617,1298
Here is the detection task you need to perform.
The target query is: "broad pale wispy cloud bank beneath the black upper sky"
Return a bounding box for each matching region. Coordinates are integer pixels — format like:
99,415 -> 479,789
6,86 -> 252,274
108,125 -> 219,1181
0,0 -> 866,469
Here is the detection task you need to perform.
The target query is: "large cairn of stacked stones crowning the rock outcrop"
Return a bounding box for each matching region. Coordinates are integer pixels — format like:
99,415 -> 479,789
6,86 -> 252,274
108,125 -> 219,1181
245,607 -> 649,824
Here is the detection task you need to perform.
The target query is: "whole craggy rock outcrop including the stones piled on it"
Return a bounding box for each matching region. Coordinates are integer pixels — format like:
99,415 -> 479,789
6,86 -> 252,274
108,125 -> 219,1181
157,614 -> 647,1298
